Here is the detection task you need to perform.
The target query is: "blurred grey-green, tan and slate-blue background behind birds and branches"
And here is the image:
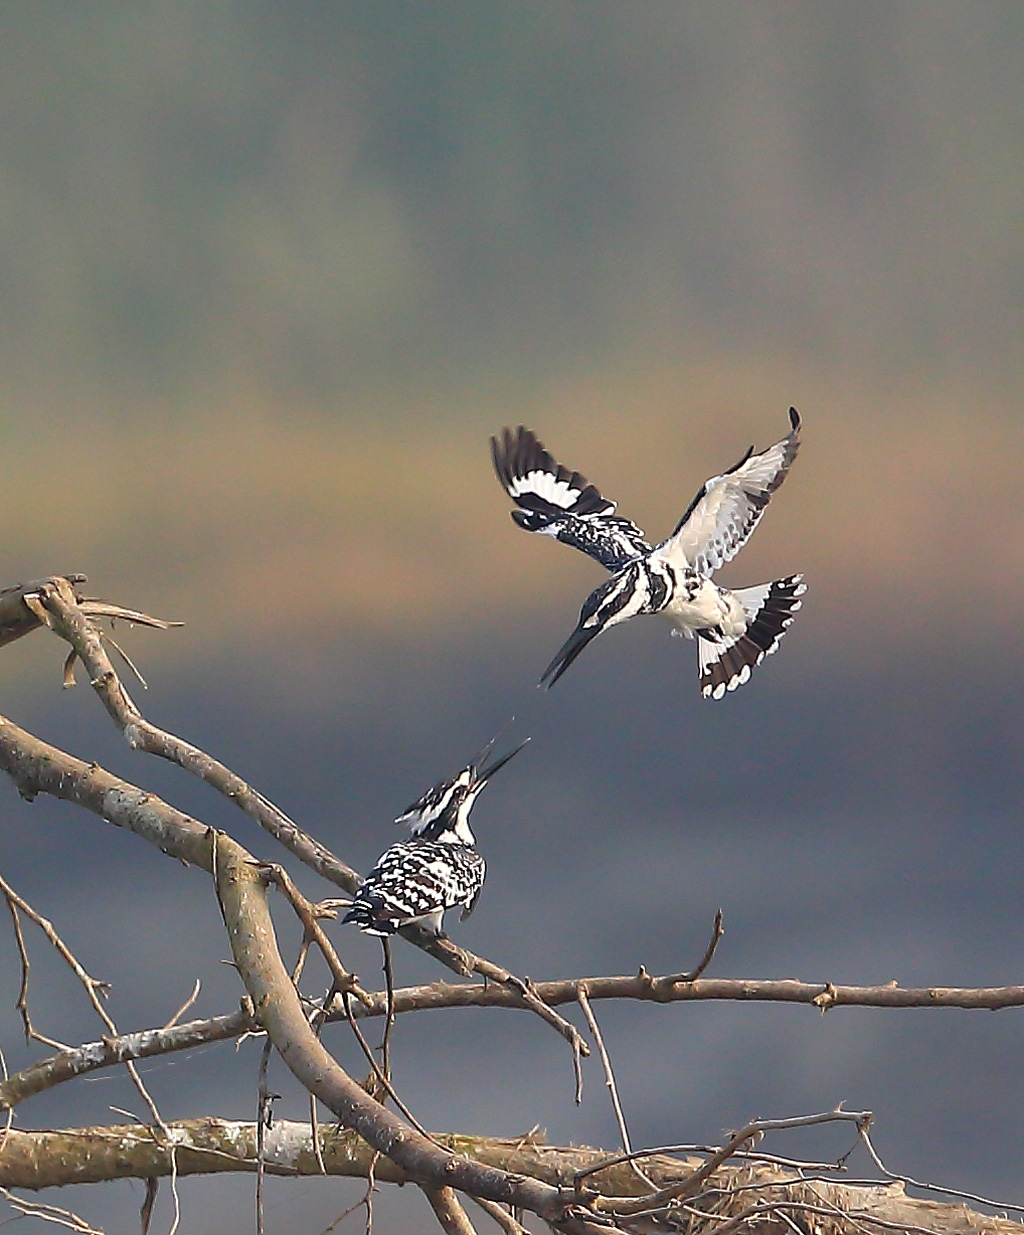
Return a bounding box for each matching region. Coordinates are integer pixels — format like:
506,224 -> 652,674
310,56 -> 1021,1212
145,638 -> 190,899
0,0 -> 1024,1233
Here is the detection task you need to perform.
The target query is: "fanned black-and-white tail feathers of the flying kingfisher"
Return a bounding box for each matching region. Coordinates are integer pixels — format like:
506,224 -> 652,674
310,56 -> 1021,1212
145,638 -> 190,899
697,574 -> 807,699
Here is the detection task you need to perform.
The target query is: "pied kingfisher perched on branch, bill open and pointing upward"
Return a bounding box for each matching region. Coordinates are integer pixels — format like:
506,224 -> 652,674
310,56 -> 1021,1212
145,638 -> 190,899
342,737 -> 530,935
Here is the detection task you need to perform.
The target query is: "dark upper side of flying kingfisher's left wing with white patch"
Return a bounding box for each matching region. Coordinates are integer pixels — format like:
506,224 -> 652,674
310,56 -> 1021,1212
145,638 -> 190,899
490,425 -> 651,571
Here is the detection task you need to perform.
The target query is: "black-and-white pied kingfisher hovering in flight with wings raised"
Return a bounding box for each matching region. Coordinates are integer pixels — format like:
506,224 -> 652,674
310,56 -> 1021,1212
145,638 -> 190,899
490,408 -> 807,699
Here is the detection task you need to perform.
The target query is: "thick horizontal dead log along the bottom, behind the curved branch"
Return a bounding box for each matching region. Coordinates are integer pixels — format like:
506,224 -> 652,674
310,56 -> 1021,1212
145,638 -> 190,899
0,1119 -> 1020,1235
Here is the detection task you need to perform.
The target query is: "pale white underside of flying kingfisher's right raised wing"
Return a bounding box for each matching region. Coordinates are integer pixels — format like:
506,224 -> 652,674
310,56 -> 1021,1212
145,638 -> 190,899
656,408 -> 800,576
